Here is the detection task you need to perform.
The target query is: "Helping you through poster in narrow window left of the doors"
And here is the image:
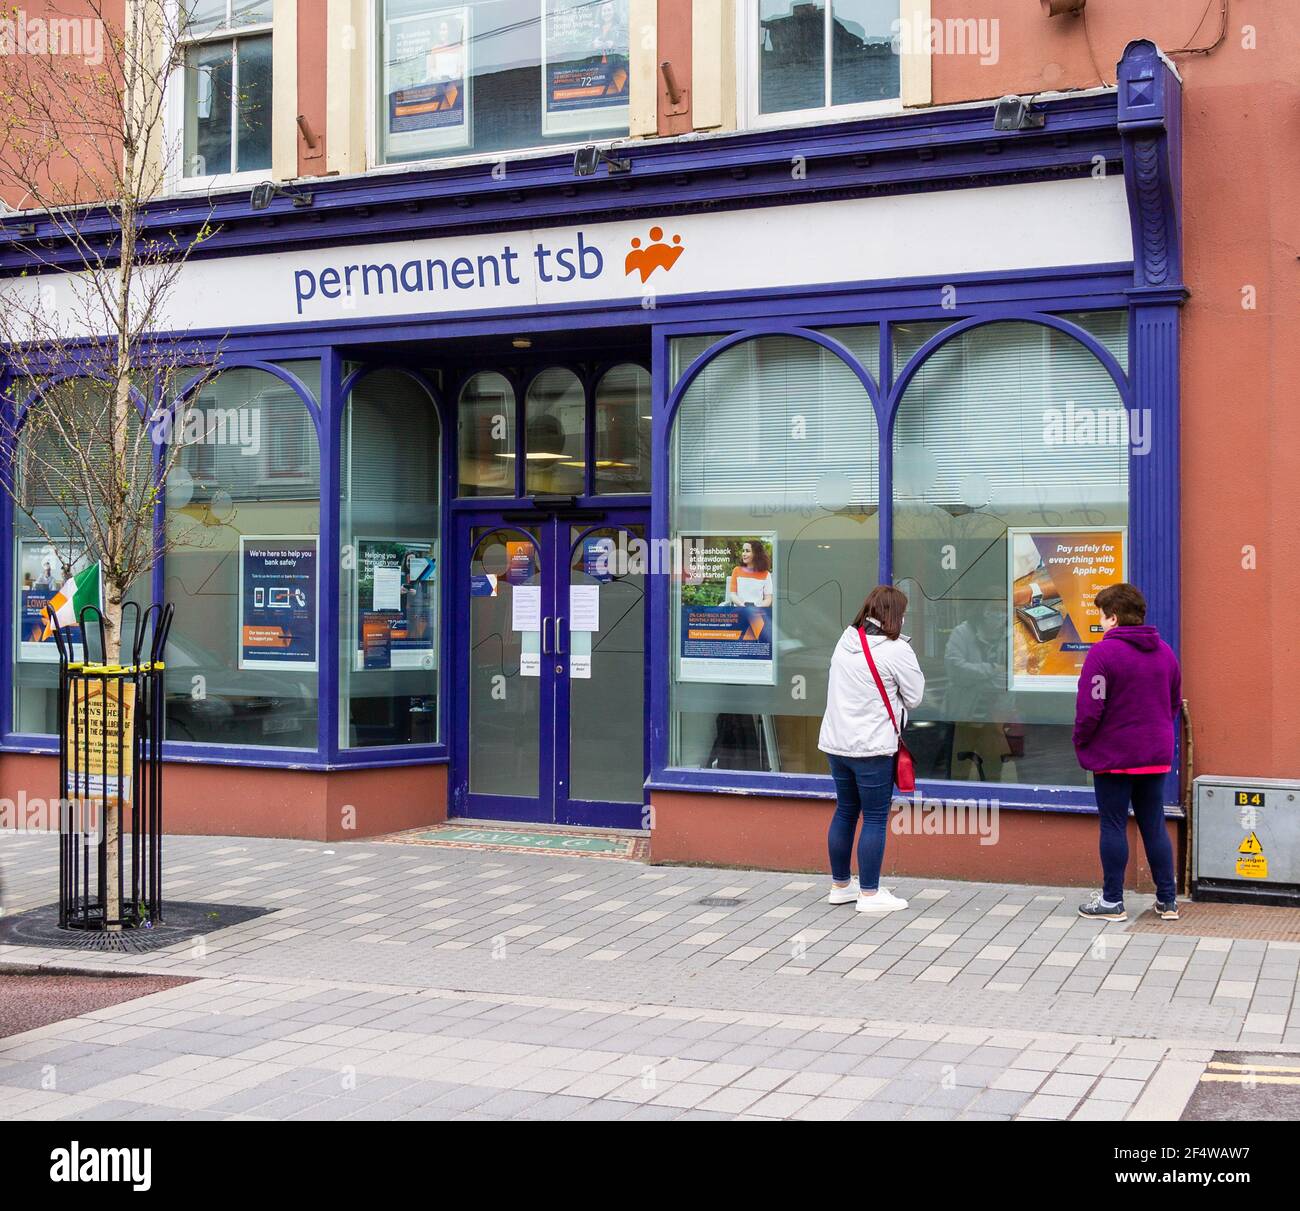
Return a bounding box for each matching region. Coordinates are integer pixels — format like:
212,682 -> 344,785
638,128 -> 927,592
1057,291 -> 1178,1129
356,538 -> 437,669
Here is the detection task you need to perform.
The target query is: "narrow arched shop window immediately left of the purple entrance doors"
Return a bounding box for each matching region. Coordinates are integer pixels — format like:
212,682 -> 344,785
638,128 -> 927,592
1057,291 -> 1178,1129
339,370 -> 442,748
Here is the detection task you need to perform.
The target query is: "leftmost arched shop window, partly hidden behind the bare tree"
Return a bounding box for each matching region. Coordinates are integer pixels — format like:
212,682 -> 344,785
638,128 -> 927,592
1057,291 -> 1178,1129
13,379 -> 153,735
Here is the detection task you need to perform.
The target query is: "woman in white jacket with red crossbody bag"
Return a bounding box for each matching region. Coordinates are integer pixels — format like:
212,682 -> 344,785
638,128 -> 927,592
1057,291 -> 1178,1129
818,585 -> 926,912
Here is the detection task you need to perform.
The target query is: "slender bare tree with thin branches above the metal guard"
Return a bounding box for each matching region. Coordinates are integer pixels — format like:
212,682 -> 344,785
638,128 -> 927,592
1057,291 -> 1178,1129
0,0 -> 217,661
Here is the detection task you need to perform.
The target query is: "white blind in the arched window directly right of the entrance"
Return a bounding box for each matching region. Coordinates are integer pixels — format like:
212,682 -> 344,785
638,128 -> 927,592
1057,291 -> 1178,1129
673,337 -> 878,508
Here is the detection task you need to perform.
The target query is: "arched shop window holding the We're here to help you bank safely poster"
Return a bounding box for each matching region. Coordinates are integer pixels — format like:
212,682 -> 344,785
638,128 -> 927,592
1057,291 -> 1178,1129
166,361 -> 321,750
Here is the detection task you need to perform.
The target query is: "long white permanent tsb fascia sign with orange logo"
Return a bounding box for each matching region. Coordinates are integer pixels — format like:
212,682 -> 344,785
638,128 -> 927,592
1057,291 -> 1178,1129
4,177 -> 1132,333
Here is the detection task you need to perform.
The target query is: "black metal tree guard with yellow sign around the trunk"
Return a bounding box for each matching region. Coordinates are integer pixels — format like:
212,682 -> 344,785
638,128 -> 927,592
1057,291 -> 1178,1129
55,602 -> 173,933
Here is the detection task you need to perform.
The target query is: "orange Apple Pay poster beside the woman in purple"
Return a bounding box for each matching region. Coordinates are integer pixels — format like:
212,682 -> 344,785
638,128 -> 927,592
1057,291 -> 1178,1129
1008,526 -> 1128,691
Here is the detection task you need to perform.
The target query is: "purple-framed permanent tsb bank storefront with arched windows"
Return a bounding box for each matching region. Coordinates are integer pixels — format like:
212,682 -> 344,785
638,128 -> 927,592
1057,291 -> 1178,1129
0,43 -> 1183,878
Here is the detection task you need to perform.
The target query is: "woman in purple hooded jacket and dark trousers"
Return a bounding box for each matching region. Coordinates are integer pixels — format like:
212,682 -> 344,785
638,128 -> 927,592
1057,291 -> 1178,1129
1074,585 -> 1183,921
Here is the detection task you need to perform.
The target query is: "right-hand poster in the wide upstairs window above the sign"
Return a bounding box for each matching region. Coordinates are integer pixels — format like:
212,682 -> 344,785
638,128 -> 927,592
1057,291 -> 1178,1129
542,0 -> 629,135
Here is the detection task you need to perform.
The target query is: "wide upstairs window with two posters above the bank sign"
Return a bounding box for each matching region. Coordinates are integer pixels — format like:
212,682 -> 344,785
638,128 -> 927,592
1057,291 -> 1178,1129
376,0 -> 629,162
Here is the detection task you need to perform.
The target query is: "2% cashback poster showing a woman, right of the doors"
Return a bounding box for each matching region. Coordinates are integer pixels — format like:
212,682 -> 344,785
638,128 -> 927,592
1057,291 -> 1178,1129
677,534 -> 776,685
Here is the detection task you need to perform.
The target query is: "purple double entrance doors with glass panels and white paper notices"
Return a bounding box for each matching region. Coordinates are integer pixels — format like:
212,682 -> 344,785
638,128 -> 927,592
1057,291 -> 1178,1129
452,509 -> 649,829
